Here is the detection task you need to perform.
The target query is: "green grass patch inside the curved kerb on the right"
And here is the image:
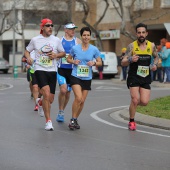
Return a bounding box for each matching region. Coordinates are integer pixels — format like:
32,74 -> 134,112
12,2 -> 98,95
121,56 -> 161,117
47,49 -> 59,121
137,96 -> 170,119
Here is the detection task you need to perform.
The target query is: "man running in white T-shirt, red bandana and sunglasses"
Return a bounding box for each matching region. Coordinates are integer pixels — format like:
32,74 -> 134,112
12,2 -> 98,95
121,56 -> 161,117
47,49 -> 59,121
25,18 -> 66,130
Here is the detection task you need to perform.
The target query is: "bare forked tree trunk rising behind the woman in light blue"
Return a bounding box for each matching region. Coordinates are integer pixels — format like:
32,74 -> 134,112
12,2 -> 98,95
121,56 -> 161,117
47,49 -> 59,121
76,0 -> 109,51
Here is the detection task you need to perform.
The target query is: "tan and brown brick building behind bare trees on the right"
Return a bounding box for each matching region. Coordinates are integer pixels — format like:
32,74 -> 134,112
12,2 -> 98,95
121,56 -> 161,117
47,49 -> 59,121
97,0 -> 170,55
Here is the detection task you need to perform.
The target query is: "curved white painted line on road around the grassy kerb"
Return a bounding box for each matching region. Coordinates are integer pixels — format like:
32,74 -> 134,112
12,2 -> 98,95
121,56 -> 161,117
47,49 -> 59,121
90,106 -> 170,138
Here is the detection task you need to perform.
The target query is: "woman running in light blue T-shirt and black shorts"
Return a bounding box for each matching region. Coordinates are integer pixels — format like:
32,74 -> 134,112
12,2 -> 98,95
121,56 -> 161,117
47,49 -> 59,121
67,27 -> 102,130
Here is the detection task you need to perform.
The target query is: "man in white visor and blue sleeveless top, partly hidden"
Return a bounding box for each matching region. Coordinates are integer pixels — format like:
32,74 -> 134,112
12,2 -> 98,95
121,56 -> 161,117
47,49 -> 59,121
56,22 -> 81,122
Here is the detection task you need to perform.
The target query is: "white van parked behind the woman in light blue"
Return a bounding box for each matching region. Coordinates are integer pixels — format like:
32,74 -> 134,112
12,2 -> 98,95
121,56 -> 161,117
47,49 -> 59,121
92,52 -> 118,78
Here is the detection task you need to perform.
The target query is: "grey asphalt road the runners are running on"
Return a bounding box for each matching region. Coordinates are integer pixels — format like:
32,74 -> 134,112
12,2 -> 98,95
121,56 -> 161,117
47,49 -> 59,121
0,74 -> 170,170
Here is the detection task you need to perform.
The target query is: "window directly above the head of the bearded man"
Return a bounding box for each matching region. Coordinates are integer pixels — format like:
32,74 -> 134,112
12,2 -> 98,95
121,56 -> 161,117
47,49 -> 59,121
134,0 -> 153,11
